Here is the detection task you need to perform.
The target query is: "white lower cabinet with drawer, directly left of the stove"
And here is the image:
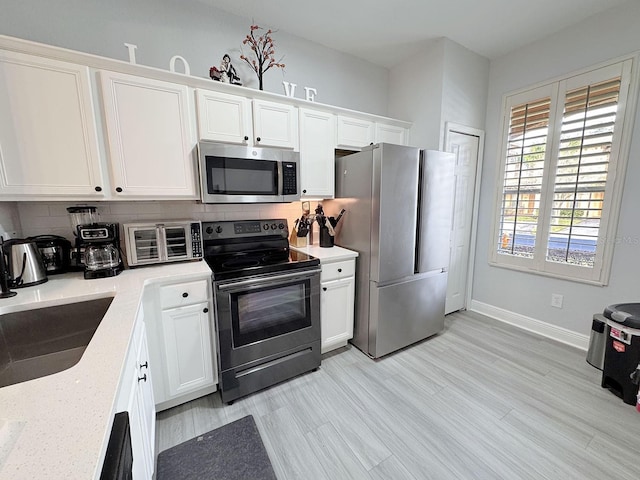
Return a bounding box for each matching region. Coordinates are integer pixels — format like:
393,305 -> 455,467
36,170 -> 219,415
145,275 -> 218,410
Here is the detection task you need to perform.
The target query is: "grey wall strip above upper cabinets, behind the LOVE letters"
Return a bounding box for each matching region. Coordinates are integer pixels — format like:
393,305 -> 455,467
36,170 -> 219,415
0,0 -> 390,115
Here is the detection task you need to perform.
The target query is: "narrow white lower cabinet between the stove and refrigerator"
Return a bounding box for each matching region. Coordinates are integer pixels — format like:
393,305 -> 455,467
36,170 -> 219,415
320,259 -> 356,353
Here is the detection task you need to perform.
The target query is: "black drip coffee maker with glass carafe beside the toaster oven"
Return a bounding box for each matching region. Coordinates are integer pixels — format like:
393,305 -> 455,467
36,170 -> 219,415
76,223 -> 124,279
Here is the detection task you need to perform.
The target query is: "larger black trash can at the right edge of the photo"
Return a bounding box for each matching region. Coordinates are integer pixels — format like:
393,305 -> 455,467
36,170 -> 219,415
602,303 -> 640,405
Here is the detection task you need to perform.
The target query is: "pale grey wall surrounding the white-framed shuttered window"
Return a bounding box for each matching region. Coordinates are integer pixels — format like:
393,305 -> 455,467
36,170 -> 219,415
472,1 -> 640,335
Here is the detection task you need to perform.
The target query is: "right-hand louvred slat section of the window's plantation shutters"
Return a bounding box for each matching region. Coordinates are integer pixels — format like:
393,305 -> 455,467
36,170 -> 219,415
546,77 -> 621,267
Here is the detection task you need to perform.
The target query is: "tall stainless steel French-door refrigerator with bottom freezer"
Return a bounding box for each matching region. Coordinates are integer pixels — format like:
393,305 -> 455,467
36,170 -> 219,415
325,143 -> 455,358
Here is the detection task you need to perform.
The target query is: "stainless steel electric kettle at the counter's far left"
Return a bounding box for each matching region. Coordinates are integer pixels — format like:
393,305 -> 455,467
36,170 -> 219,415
4,238 -> 48,288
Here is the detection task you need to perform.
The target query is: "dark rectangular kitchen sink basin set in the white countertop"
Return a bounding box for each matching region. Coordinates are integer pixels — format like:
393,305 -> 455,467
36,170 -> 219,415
0,297 -> 113,387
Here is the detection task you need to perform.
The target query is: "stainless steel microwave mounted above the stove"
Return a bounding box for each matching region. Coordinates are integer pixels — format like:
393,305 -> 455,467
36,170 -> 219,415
198,142 -> 300,203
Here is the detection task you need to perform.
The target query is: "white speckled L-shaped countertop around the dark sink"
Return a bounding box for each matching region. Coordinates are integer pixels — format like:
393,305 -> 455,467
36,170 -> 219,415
0,261 -> 211,480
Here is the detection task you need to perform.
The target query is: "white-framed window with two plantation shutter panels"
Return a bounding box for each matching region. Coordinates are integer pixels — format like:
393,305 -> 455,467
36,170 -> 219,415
491,59 -> 632,285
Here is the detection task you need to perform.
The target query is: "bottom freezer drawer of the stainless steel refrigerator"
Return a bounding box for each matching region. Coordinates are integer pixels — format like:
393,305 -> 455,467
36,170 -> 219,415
367,272 -> 447,358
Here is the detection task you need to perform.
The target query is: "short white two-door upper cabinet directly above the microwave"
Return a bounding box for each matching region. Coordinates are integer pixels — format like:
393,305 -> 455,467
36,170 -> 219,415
196,89 -> 298,150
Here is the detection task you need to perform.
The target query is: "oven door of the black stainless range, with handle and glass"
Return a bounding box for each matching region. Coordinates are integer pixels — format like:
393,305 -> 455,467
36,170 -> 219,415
214,268 -> 320,371
